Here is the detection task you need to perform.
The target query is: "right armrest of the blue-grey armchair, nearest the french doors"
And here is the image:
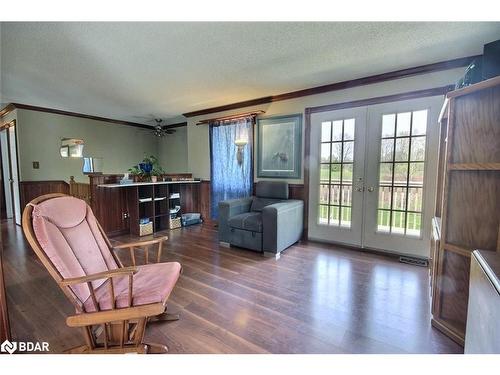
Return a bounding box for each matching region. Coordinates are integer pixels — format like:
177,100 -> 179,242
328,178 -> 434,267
262,199 -> 304,253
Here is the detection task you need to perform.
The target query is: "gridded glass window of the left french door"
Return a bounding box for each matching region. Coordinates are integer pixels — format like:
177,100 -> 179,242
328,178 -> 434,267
318,119 -> 355,228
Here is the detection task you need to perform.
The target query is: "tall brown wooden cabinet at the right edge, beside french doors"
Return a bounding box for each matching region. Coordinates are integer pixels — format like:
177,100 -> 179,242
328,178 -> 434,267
432,77 -> 500,345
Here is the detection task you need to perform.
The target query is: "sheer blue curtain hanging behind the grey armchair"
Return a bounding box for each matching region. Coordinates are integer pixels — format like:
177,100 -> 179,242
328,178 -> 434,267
210,117 -> 254,219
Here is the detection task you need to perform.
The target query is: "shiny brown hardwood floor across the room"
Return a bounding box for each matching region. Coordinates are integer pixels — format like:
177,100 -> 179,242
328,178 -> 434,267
1,221 -> 463,353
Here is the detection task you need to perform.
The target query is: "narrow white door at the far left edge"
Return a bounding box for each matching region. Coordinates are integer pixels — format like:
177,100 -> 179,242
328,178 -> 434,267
0,120 -> 21,225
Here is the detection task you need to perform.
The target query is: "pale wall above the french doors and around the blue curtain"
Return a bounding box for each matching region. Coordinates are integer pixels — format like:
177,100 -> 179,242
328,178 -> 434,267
187,68 -> 464,184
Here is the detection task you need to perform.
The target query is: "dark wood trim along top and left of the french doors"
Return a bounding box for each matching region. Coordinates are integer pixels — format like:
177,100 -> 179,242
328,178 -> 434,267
303,85 -> 455,245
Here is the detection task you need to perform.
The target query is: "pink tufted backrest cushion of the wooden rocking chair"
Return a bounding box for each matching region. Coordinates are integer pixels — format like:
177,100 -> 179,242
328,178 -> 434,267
32,196 -> 118,302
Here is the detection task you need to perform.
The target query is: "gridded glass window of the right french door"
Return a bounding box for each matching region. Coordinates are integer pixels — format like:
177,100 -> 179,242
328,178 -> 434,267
377,110 -> 428,236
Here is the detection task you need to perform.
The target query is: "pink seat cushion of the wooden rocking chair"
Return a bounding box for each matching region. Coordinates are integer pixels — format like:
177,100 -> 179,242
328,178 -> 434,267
84,262 -> 181,312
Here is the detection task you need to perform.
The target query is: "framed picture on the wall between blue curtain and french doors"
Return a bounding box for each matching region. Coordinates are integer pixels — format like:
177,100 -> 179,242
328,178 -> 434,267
257,114 -> 302,178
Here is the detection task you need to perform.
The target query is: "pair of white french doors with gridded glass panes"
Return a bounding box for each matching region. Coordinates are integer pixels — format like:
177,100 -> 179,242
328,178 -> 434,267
309,96 -> 443,257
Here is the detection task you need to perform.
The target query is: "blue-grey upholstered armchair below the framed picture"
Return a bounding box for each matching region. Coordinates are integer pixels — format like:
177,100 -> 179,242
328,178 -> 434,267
219,181 -> 304,258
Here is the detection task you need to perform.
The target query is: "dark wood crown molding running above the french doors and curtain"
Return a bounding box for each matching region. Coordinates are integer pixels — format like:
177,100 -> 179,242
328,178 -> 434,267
183,56 -> 480,117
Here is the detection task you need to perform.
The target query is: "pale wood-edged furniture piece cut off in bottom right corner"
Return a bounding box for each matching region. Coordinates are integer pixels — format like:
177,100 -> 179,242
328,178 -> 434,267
465,250 -> 500,354
